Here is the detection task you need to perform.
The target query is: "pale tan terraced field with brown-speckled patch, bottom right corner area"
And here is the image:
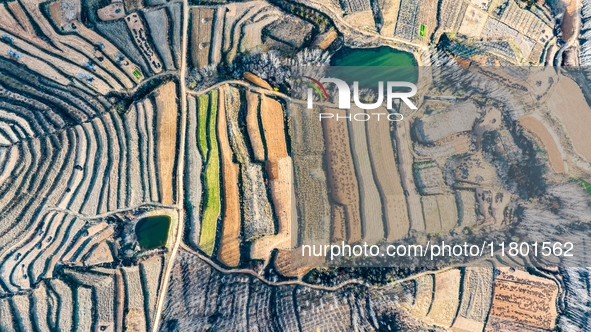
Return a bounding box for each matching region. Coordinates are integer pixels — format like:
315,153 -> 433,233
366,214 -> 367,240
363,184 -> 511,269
390,263 -> 556,331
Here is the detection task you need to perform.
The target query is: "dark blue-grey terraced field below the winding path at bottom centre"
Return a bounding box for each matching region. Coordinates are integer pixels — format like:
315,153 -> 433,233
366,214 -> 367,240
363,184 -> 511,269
160,251 -> 424,331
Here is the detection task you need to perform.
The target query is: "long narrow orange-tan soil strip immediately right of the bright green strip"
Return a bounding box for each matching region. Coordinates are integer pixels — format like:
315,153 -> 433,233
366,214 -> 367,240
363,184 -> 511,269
217,88 -> 240,266
